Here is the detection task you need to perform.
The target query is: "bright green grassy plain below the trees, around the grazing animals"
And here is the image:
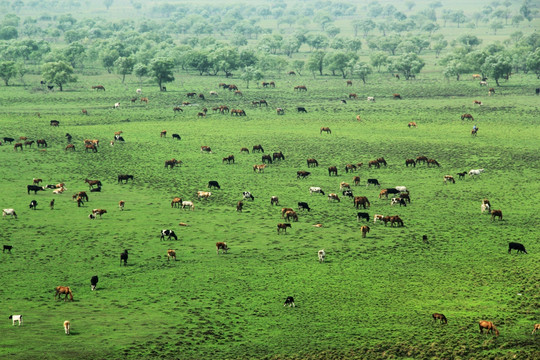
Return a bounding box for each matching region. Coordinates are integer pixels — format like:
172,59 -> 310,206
0,74 -> 540,359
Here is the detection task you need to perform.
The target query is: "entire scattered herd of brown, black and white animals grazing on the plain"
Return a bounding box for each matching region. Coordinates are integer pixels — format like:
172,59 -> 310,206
2,81 -> 540,344
